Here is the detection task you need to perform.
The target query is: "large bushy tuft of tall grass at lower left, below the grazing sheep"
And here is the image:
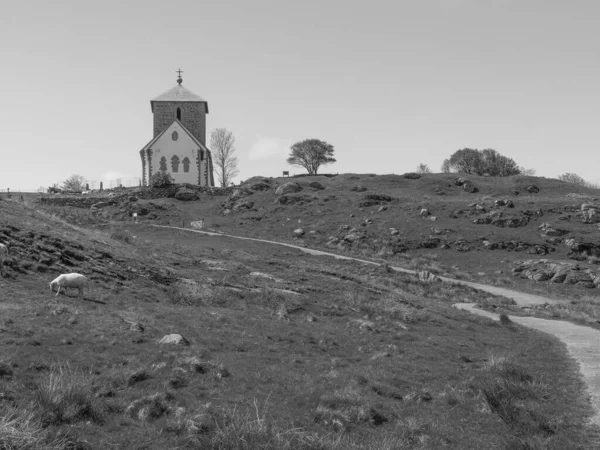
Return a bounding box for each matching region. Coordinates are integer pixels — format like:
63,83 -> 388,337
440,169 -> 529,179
36,365 -> 103,425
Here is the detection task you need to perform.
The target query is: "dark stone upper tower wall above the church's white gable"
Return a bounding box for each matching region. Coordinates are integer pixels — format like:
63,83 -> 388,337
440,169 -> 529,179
154,102 -> 206,145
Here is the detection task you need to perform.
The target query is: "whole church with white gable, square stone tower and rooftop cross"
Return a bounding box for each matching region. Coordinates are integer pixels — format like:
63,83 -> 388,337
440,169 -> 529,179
140,70 -> 215,186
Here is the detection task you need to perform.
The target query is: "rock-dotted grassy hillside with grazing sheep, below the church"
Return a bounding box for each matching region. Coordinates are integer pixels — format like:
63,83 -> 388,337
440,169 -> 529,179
0,175 -> 597,449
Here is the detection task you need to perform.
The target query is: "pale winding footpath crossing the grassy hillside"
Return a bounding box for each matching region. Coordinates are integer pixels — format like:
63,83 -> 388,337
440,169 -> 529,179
154,225 -> 600,425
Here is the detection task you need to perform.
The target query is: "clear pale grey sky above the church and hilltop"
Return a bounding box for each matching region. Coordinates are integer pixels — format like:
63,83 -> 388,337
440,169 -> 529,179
0,0 -> 600,191
